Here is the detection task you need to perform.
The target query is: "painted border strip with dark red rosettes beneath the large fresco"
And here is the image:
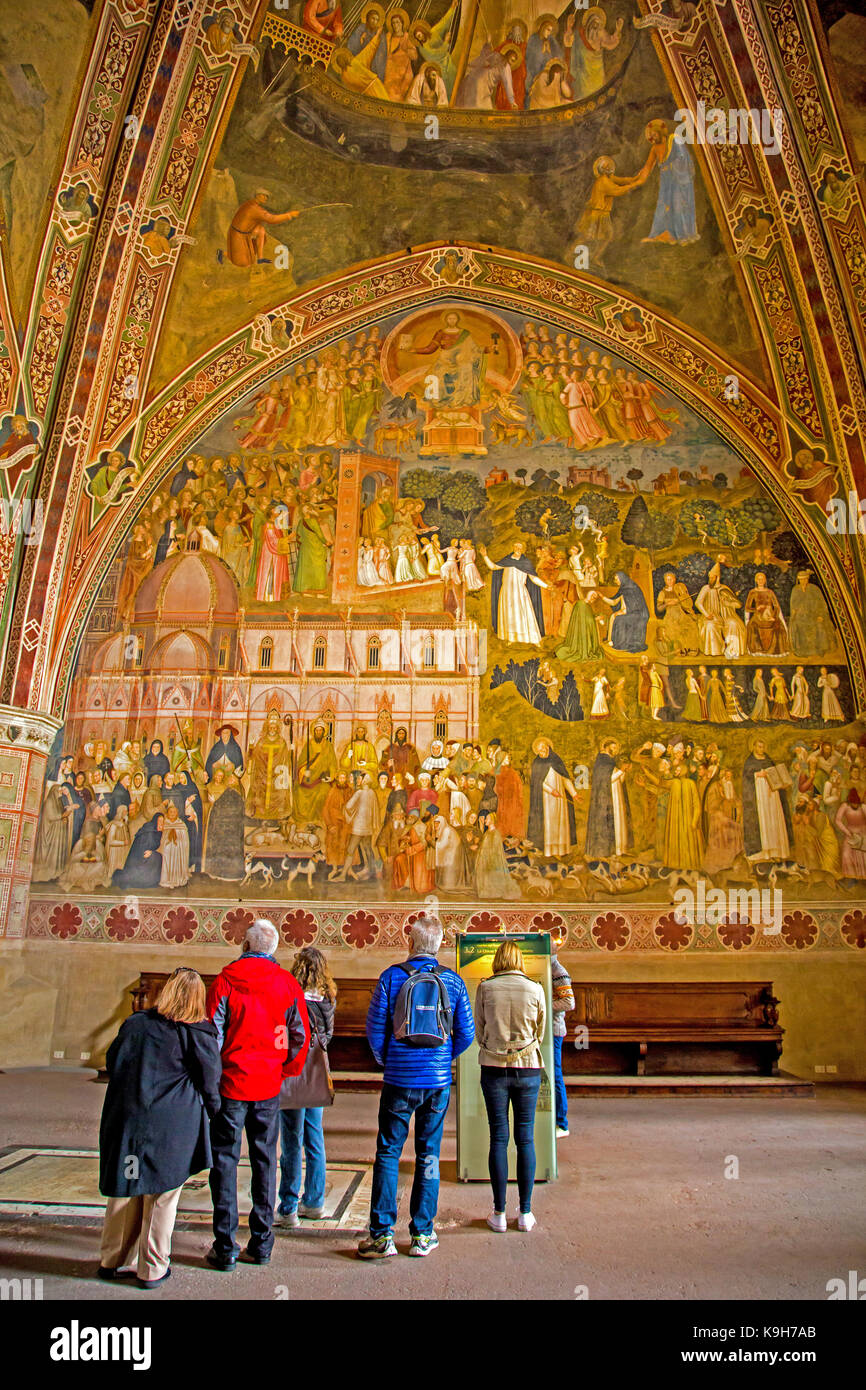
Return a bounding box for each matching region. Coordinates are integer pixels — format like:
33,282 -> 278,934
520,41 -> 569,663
26,892 -> 866,955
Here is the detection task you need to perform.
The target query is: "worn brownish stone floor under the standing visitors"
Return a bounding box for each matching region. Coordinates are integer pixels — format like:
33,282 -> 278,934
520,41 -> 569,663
0,1070 -> 866,1302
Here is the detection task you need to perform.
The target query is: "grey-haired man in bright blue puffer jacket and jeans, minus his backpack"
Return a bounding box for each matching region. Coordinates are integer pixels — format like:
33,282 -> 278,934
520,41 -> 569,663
357,916 -> 475,1259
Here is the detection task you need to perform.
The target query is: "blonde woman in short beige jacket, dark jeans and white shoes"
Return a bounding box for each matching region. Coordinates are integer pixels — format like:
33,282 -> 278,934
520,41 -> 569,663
475,941 -> 545,1232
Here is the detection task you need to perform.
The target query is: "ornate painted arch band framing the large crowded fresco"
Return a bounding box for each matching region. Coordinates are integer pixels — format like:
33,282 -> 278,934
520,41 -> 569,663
23,243 -> 866,709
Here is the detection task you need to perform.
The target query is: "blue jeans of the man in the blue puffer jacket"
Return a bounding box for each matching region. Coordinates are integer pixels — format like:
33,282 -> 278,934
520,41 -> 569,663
370,1081 -> 450,1240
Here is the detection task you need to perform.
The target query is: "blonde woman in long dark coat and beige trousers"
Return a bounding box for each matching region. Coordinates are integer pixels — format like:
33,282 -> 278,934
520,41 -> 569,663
97,966 -> 221,1289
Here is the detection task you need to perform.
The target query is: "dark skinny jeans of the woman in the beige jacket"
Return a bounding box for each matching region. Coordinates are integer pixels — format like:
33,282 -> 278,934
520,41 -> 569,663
481,1066 -> 541,1212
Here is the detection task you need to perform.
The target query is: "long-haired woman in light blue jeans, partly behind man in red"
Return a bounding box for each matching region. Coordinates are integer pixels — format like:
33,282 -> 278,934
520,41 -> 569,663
277,947 -> 336,1227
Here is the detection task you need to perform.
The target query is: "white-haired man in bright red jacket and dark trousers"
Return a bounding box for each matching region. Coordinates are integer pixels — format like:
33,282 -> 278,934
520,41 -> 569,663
206,917 -> 310,1272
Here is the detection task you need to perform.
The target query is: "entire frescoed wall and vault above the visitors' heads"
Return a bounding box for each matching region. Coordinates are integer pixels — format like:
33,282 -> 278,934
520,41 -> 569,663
0,0 -> 866,949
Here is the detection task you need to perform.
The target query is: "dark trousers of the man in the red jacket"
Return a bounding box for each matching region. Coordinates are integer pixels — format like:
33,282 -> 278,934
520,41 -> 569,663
210,1095 -> 279,1258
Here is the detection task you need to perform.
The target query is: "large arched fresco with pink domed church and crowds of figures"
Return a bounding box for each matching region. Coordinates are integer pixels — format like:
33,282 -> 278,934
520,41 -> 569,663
36,301 -> 866,905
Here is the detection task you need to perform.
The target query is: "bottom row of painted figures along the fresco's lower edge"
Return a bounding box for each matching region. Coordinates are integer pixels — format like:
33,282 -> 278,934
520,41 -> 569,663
35,710 -> 866,901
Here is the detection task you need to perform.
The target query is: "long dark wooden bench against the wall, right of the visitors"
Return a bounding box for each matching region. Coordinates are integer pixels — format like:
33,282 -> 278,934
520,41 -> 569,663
563,980 -> 784,1076
